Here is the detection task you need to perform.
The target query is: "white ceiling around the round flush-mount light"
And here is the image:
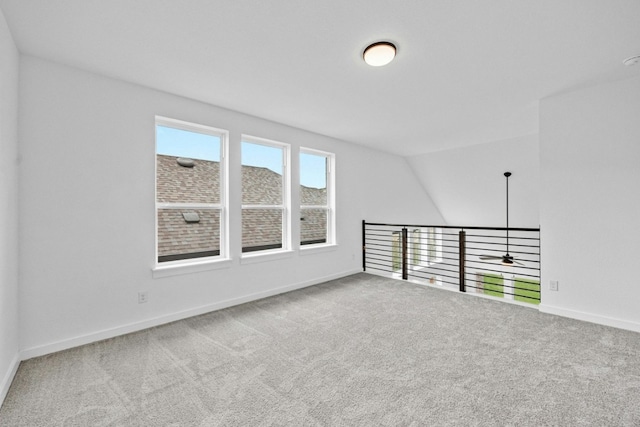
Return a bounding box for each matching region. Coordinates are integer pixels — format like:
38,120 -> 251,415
0,0 -> 640,156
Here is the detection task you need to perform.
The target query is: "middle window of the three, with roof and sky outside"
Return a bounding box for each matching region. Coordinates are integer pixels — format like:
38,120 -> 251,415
242,136 -> 290,252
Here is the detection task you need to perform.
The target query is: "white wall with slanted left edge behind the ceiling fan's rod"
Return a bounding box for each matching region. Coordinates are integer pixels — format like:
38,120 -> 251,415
408,135 -> 540,228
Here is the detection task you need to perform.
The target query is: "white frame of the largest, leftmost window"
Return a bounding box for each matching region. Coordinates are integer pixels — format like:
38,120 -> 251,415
153,116 -> 230,270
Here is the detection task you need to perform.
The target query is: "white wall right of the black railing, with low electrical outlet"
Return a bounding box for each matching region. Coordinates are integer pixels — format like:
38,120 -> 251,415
540,78 -> 640,331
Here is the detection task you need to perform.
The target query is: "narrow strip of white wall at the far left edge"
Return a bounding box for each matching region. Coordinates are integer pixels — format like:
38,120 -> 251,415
0,7 -> 19,404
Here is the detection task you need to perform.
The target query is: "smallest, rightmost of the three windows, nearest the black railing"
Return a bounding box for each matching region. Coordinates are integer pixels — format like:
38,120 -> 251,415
300,148 -> 335,245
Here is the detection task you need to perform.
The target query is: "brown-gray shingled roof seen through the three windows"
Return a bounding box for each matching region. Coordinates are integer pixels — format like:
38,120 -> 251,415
156,154 -> 327,261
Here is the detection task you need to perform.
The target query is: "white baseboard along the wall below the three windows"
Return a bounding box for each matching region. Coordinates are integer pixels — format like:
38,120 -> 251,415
20,270 -> 362,362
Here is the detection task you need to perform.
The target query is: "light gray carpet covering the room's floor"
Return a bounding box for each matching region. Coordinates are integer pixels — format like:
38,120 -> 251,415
0,274 -> 640,426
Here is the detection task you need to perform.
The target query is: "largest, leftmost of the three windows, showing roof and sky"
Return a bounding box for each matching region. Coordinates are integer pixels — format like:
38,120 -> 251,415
156,117 -> 227,263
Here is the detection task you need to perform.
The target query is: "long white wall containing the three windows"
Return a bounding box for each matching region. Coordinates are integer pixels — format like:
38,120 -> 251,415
19,57 -> 442,357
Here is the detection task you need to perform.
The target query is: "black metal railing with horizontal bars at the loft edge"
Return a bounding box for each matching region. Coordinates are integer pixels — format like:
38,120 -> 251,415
362,221 -> 540,304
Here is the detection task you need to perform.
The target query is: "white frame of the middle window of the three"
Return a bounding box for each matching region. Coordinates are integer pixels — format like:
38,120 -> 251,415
240,134 -> 291,259
